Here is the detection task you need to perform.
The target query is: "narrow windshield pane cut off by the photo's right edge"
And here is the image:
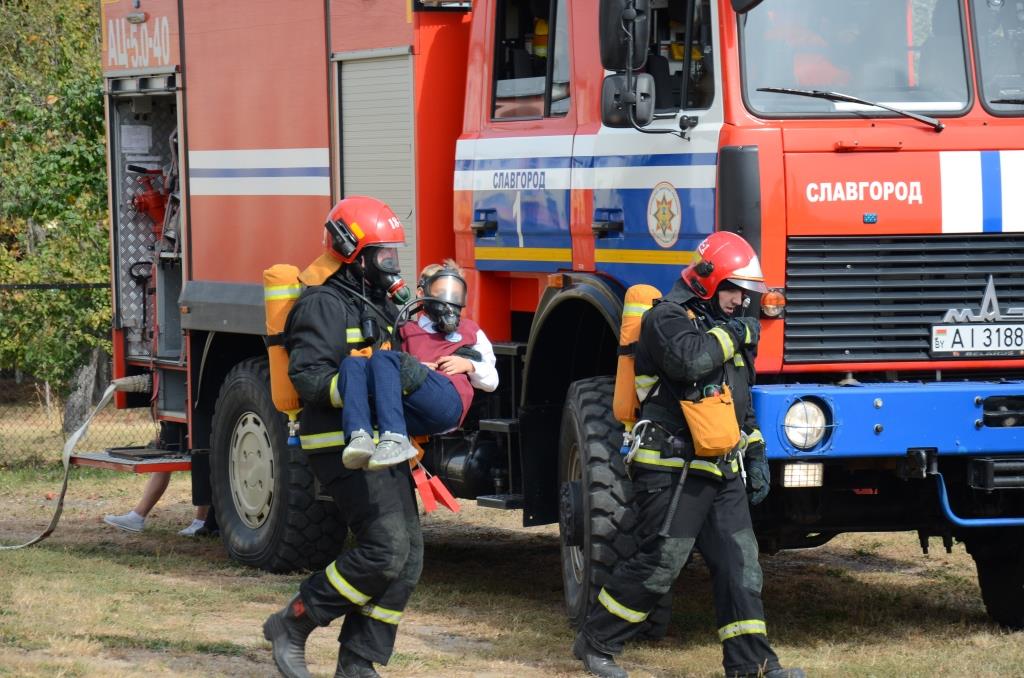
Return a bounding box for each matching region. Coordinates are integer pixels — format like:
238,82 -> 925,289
971,0 -> 1024,115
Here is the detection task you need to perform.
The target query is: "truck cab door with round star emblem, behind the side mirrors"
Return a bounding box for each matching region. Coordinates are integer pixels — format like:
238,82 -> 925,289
573,0 -> 723,292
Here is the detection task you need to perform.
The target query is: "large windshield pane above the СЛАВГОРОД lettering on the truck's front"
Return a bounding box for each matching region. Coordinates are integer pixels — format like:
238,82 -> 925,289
739,0 -> 966,116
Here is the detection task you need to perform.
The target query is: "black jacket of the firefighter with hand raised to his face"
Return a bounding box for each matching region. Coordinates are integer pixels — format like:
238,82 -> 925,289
633,280 -> 761,485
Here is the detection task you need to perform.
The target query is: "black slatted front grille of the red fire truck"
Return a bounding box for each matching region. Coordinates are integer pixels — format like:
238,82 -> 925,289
783,234 -> 1024,363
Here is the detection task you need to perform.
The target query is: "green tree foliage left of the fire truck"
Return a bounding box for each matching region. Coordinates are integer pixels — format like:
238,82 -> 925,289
0,0 -> 111,389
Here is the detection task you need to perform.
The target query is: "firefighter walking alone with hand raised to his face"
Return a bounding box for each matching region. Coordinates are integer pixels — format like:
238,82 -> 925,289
572,232 -> 804,678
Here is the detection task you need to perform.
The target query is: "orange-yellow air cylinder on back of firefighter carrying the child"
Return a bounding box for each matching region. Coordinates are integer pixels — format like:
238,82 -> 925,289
263,263 -> 302,422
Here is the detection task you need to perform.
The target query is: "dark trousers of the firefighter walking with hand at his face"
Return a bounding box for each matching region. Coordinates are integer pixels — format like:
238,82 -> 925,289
581,470 -> 779,676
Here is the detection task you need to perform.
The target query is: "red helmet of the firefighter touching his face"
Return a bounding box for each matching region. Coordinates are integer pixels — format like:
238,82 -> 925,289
683,230 -> 768,299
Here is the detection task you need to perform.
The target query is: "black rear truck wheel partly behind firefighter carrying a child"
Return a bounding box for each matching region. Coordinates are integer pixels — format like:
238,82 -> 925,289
210,358 -> 347,573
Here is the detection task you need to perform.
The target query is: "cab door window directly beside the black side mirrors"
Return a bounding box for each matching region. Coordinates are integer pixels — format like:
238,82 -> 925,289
646,0 -> 715,113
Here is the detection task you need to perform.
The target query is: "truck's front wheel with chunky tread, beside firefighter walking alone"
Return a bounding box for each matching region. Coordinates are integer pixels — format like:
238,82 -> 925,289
558,377 -> 672,640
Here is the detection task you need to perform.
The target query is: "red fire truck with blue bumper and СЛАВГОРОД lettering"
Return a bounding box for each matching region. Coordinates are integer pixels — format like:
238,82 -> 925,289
92,0 -> 1024,634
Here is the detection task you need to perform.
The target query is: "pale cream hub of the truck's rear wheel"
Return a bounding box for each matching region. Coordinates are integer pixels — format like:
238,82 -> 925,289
228,412 -> 275,529
